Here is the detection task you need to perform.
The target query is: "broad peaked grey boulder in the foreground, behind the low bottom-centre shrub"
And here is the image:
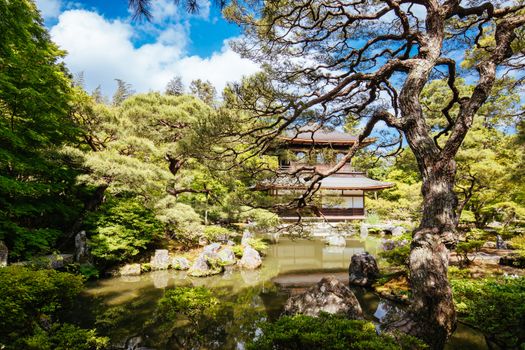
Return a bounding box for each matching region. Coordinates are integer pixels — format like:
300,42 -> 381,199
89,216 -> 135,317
284,276 -> 363,319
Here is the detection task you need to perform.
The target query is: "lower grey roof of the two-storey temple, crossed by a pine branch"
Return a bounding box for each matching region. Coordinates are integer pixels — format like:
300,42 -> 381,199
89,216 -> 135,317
260,173 -> 394,191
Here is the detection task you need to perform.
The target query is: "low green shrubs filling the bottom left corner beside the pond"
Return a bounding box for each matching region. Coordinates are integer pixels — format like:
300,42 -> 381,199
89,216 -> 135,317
0,266 -> 105,350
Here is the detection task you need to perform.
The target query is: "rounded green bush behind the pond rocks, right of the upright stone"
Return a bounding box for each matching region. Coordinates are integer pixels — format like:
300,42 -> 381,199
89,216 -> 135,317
85,198 -> 162,263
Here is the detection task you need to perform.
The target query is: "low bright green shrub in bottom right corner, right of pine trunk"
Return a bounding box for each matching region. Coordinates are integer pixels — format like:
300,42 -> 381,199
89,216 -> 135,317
451,277 -> 525,349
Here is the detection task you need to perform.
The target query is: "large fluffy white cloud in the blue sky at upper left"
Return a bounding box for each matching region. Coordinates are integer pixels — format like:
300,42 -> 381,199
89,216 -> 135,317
51,8 -> 257,95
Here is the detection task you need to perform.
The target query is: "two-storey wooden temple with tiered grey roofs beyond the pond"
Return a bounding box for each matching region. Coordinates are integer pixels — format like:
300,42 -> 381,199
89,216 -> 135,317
258,130 -> 393,221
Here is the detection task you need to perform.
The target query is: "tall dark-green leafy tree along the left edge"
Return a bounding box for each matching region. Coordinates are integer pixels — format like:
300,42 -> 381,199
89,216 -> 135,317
0,0 -> 82,260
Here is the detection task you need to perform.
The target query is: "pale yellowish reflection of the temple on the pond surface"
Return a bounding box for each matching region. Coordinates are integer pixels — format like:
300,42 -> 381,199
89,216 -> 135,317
268,239 -> 377,273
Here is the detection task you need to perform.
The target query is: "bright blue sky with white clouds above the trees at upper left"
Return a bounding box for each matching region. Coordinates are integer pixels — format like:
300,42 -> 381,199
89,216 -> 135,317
36,0 -> 258,96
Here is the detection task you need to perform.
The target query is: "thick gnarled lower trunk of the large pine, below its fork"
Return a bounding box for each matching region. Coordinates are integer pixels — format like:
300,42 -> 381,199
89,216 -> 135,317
409,160 -> 457,349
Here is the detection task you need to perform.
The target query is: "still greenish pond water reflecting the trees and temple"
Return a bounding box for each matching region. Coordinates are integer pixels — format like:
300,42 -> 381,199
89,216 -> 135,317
70,237 -> 487,350
